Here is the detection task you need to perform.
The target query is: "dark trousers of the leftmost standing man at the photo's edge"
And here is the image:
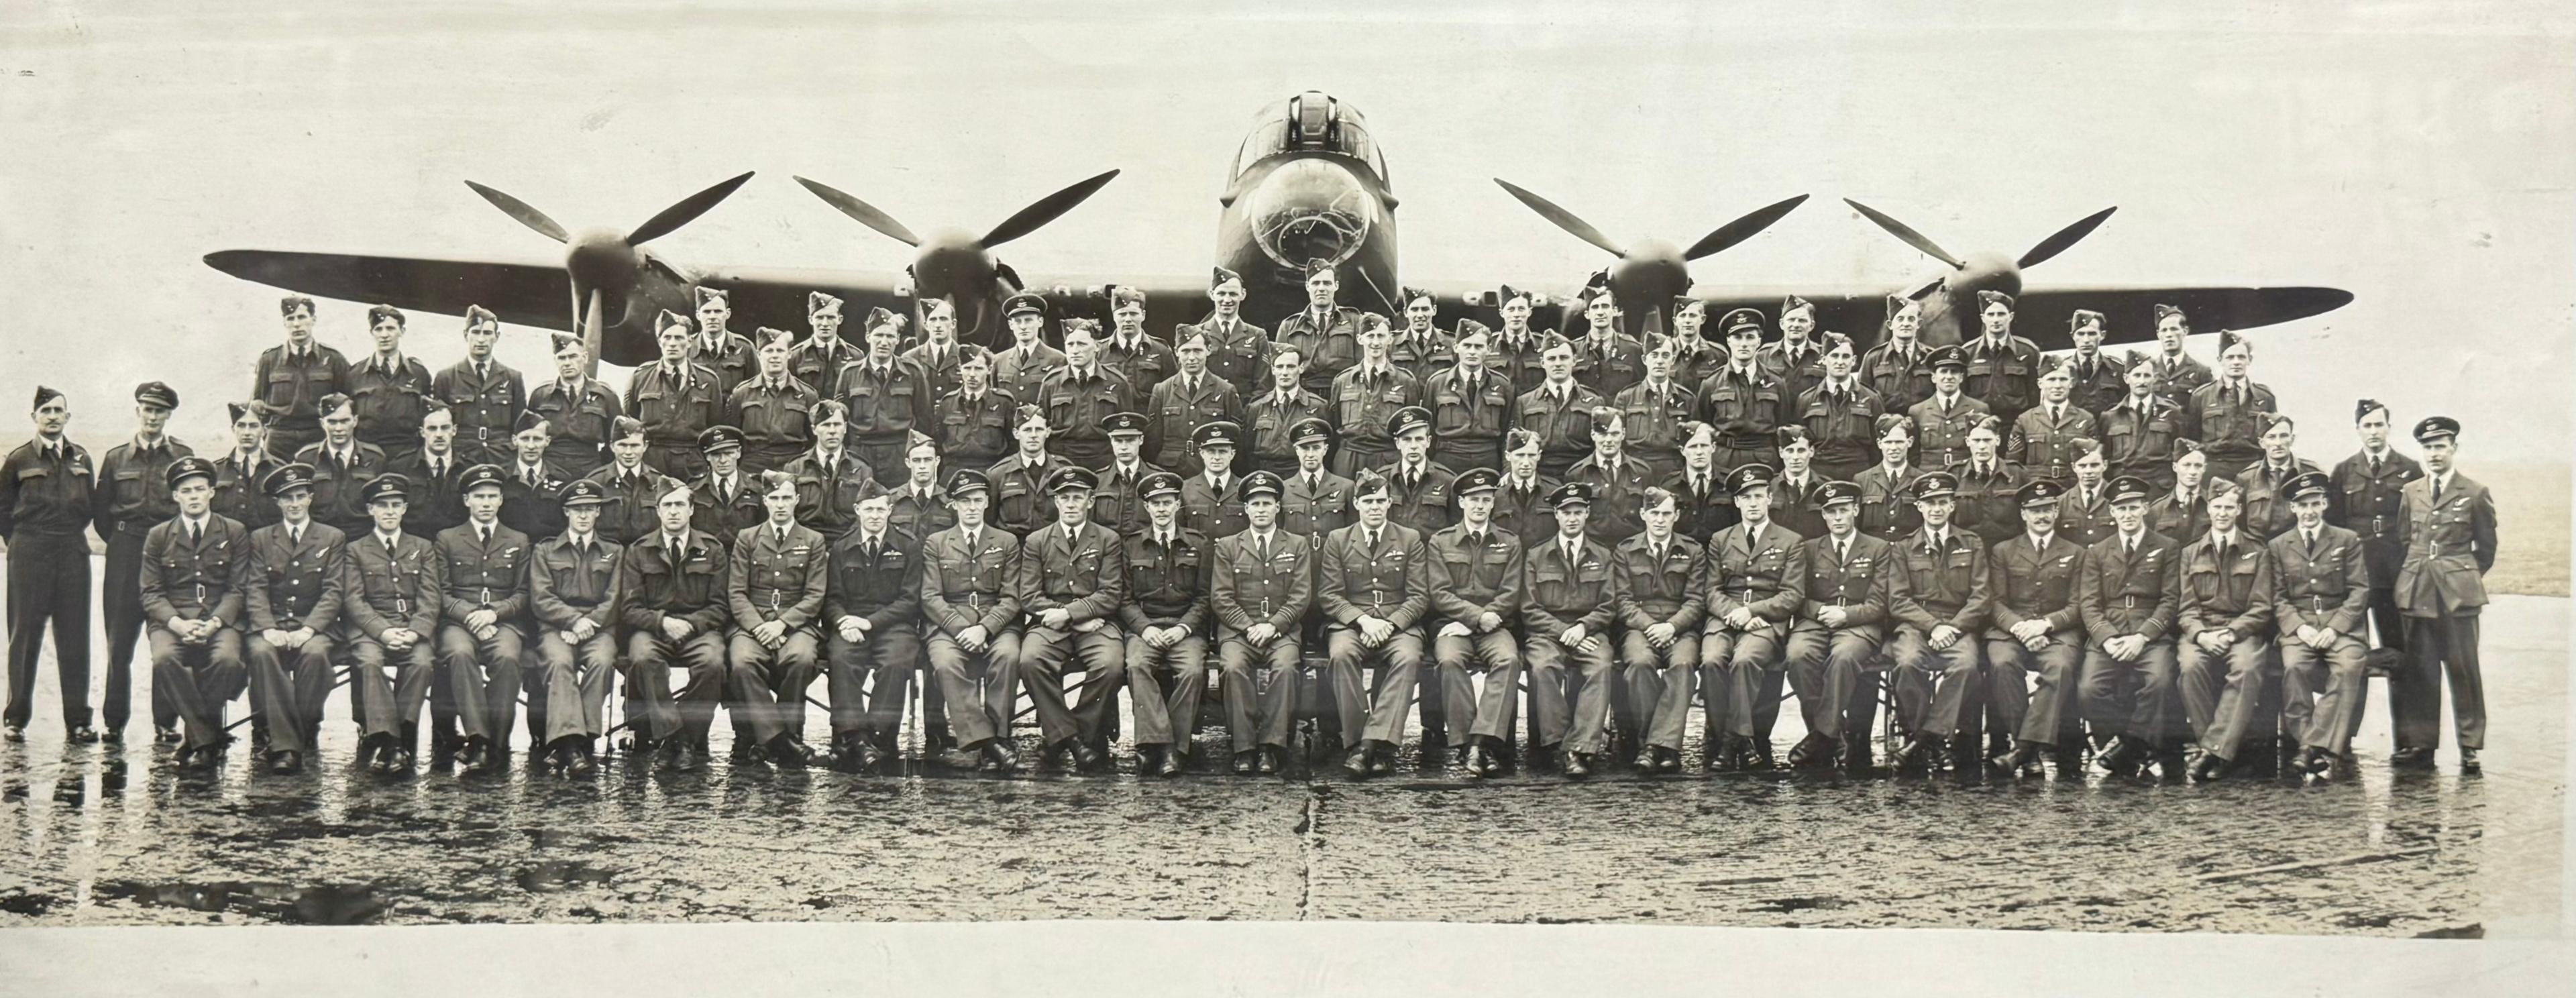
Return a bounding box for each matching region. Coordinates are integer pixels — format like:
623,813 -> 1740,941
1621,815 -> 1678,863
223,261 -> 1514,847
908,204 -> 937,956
5,530 -> 92,730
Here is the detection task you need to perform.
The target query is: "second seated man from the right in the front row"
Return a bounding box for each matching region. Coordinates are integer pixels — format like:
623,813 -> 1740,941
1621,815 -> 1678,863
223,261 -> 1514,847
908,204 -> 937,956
2174,486 -> 2275,779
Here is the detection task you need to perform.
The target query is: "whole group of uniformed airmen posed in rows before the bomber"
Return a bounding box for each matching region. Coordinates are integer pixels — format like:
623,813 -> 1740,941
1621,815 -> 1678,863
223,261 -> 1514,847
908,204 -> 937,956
0,265 -> 2496,779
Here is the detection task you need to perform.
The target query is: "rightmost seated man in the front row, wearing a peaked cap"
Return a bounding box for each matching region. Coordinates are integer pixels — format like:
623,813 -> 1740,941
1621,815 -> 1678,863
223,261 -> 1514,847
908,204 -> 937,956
2269,471 -> 2370,777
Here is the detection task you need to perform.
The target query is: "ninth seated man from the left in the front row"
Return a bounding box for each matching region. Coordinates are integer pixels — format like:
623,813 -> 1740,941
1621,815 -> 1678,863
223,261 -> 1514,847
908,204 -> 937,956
920,470 -> 1020,772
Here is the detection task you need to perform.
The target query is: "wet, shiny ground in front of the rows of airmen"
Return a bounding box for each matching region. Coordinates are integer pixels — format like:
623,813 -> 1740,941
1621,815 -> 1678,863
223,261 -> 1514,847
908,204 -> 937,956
0,600 -> 2566,936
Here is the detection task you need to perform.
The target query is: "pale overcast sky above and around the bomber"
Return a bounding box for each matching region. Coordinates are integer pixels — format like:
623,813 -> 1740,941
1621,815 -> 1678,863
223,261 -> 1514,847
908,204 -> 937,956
0,0 -> 2576,460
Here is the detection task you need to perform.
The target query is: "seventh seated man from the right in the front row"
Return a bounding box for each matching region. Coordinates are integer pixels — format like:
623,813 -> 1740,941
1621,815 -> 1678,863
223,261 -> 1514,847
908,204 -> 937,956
1700,463 -> 1806,769
